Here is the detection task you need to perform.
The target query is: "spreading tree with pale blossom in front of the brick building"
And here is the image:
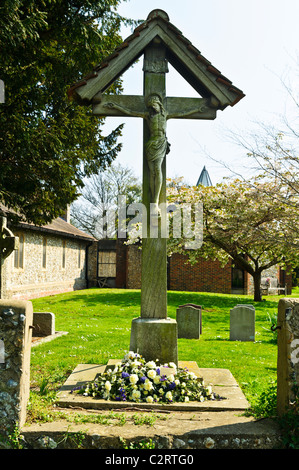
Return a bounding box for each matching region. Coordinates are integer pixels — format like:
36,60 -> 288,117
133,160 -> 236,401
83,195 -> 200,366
168,177 -> 299,301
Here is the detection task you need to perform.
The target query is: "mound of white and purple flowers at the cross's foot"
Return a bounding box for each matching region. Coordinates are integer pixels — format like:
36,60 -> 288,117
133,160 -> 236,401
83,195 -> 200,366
73,351 -> 223,403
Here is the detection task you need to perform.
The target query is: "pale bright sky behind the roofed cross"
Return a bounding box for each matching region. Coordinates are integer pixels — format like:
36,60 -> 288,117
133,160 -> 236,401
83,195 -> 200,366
104,0 -> 299,184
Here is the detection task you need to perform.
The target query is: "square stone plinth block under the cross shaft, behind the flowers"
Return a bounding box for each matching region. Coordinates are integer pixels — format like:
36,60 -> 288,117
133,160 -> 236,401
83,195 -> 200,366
130,317 -> 178,364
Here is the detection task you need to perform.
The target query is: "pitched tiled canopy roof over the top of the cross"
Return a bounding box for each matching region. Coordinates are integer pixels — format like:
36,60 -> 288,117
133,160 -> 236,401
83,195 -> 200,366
69,10 -> 245,109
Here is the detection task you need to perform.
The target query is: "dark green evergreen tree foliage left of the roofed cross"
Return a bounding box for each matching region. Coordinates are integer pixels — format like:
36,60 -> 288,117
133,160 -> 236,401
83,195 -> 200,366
0,0 -> 137,224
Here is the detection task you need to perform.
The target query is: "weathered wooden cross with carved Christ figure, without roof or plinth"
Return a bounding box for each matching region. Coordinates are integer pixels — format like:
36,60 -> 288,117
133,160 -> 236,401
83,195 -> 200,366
93,38 -> 217,319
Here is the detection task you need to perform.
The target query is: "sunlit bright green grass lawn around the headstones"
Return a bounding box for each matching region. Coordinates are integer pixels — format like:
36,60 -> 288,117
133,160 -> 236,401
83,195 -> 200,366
30,289 -> 299,419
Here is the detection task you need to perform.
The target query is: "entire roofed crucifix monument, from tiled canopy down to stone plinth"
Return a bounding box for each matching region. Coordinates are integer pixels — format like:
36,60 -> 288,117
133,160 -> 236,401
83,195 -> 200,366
69,9 -> 244,364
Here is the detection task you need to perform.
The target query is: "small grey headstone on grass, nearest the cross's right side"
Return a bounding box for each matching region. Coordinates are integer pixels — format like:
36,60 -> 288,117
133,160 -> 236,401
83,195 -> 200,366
176,304 -> 202,339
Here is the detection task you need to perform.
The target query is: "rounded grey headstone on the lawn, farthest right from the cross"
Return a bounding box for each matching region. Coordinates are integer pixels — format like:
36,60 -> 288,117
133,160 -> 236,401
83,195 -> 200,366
229,304 -> 255,341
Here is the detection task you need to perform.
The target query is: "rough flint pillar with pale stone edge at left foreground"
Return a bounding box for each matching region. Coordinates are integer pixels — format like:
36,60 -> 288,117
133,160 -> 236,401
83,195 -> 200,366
0,300 -> 33,435
